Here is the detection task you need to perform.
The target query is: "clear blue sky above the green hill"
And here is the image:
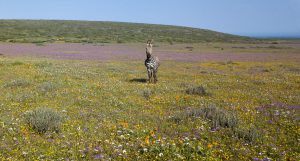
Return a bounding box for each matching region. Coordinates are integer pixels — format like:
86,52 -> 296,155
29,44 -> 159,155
0,0 -> 300,37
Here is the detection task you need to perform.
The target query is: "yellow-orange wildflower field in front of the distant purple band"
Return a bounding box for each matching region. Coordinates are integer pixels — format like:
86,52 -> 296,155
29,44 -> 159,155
0,42 -> 300,161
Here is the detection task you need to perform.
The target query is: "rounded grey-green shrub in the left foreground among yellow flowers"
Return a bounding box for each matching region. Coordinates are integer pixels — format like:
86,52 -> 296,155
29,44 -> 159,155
24,108 -> 62,133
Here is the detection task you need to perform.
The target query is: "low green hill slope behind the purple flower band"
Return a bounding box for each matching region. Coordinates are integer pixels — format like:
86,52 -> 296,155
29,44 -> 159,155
0,20 -> 253,43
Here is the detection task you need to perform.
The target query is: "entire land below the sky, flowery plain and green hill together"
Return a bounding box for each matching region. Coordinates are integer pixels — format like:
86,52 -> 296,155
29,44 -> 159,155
0,20 -> 300,161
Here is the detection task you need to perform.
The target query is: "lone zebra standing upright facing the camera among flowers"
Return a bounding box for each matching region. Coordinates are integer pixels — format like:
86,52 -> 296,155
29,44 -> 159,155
145,40 -> 160,83
